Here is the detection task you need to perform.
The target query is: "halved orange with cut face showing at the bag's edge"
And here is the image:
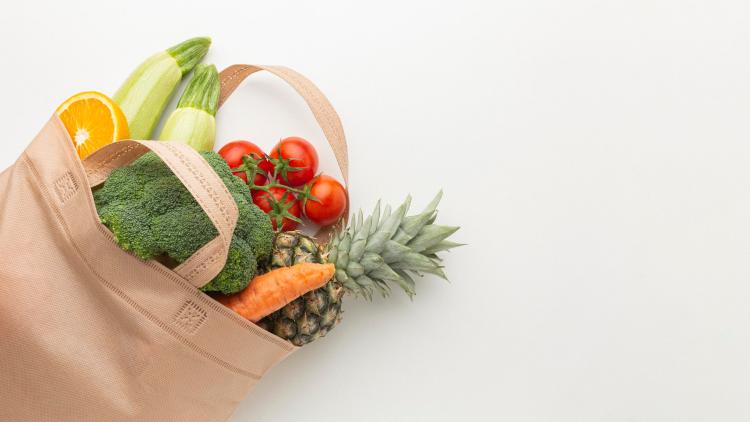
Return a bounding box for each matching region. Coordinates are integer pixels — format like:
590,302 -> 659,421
56,91 -> 129,160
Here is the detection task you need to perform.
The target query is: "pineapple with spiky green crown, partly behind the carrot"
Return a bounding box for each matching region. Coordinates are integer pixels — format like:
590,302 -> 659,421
258,192 -> 460,346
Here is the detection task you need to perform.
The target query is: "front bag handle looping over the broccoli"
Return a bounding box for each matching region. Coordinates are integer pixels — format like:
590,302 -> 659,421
83,140 -> 238,288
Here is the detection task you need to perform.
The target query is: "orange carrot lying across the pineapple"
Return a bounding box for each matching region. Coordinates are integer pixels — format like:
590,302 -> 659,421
217,263 -> 336,322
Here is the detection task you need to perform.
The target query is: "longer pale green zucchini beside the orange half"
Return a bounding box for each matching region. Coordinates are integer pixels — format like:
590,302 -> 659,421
114,37 -> 211,139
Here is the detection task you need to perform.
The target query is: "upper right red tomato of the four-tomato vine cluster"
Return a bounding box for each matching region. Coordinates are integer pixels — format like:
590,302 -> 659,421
270,136 -> 318,186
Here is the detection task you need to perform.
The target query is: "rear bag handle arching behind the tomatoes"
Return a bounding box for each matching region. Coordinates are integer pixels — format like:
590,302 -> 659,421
219,64 -> 349,242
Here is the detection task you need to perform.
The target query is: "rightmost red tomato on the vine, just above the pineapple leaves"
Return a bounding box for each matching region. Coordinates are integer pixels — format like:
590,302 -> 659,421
304,174 -> 346,226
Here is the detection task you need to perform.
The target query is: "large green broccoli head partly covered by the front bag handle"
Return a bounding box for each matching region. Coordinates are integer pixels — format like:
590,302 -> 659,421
94,152 -> 274,294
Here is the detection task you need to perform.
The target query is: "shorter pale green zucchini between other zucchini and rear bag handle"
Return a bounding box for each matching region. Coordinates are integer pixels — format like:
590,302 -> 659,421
159,65 -> 221,151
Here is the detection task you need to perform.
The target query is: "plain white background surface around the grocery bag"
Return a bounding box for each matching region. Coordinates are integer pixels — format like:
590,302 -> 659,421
0,0 -> 750,422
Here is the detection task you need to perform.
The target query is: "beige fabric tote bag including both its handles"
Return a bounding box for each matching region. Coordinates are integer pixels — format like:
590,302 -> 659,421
0,65 -> 347,422
